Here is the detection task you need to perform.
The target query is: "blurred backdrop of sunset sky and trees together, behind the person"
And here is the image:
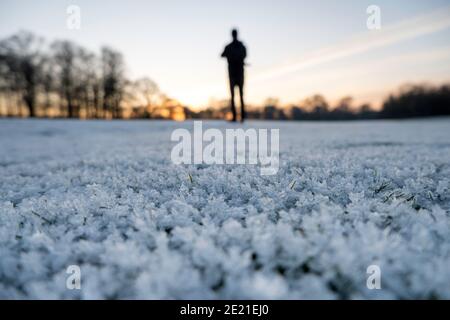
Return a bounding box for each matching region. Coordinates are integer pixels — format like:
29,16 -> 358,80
0,0 -> 450,120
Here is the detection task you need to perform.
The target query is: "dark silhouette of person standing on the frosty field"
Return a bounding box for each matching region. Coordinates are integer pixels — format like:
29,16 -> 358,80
222,29 -> 247,122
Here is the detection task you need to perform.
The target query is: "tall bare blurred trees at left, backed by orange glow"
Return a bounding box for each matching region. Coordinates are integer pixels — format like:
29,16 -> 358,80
0,31 -> 159,118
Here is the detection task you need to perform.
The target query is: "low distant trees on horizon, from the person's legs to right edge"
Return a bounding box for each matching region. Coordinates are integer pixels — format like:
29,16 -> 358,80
190,85 -> 450,120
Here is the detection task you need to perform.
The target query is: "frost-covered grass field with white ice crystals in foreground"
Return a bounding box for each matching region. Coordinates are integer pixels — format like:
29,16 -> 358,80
0,118 -> 450,299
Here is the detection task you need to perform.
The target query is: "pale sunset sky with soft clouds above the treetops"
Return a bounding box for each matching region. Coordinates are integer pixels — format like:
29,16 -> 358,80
0,0 -> 450,108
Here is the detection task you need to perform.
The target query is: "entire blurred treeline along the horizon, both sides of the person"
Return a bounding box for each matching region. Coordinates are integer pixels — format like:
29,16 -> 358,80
0,31 -> 450,120
